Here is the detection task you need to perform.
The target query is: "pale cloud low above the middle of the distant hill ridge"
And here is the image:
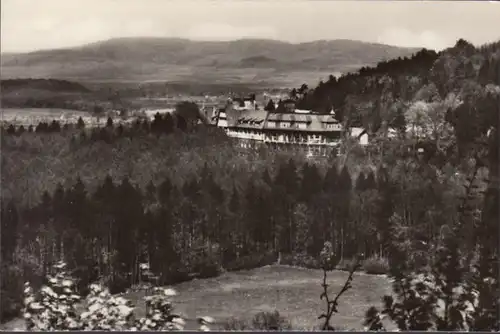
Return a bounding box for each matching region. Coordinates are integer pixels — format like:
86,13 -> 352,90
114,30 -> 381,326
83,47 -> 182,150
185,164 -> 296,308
186,23 -> 278,41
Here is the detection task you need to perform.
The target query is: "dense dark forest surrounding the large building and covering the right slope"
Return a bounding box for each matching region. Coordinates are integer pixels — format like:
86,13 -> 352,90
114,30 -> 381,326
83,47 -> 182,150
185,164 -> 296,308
1,40 -> 500,329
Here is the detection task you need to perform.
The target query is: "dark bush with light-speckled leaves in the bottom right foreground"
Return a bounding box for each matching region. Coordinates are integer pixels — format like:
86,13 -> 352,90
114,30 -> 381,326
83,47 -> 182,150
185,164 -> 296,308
364,228 -> 478,331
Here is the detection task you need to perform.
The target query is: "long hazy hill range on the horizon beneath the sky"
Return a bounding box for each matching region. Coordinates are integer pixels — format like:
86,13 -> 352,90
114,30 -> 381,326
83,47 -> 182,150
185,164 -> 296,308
1,38 -> 418,85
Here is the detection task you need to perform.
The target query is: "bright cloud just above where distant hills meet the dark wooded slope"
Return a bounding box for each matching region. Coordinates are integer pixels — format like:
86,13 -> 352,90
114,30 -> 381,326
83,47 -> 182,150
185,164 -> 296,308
377,28 -> 451,51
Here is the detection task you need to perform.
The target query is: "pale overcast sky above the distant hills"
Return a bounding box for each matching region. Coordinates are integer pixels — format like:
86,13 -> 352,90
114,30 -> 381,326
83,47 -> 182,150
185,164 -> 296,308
1,0 -> 500,52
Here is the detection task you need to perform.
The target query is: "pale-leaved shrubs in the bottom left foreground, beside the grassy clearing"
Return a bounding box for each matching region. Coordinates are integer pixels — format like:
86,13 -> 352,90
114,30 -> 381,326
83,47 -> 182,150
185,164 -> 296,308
24,262 -> 220,331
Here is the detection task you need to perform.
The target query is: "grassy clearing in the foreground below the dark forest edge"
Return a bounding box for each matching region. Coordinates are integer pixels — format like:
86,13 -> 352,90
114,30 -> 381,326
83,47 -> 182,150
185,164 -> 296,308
2,265 -> 390,330
